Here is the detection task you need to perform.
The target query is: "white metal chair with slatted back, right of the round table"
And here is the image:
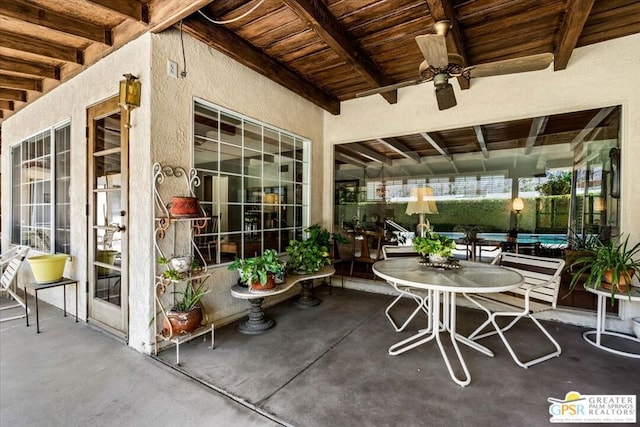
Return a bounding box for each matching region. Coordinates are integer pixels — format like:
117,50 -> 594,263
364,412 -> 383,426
464,252 -> 564,368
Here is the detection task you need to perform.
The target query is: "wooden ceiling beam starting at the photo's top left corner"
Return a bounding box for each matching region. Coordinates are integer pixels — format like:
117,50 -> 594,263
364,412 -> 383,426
0,0 -> 113,46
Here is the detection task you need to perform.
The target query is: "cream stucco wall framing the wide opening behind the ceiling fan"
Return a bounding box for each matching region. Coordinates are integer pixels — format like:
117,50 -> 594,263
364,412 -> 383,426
324,34 -> 640,332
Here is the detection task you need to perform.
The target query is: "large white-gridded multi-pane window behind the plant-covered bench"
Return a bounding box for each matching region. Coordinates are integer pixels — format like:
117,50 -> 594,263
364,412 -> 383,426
193,101 -> 310,264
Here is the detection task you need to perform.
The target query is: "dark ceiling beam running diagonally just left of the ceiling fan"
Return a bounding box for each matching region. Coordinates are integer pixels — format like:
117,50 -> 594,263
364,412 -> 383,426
283,0 -> 398,104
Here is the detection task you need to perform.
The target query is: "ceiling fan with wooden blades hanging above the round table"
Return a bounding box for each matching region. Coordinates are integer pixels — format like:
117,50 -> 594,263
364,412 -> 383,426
356,21 -> 553,110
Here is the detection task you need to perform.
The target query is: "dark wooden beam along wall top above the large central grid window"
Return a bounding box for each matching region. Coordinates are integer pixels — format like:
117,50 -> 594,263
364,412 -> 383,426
183,15 -> 340,115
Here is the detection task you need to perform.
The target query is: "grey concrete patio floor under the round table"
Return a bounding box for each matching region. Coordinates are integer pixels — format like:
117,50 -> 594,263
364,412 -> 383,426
0,280 -> 640,427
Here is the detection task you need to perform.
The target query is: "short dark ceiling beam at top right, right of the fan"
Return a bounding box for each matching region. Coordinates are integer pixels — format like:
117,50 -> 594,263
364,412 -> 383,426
553,0 -> 595,71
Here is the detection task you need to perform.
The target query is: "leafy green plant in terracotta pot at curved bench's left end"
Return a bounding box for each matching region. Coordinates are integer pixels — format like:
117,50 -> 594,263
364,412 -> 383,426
228,249 -> 285,291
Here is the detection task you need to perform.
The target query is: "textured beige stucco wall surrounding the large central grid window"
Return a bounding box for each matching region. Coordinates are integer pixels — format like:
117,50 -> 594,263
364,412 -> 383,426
130,30 -> 331,351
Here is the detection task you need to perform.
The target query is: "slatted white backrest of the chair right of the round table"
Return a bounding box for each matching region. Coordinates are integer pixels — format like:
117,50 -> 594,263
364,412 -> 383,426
492,252 -> 564,308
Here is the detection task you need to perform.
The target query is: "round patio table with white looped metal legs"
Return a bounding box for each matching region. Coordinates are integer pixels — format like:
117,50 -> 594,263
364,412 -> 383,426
373,257 -> 524,387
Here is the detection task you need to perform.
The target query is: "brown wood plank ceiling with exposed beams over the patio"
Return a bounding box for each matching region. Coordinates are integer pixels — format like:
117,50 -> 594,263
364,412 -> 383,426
0,0 -> 640,166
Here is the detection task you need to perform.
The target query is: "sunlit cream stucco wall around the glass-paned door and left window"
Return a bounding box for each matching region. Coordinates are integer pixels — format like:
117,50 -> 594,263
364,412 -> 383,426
2,35 -> 151,328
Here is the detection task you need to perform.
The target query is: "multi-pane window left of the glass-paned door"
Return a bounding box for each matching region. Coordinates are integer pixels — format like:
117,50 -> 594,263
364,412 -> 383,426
11,123 -> 71,254
